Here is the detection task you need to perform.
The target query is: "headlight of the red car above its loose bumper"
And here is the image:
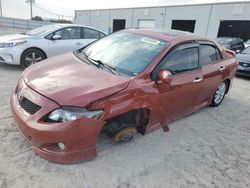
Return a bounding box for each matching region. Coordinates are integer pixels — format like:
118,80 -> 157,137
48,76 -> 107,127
47,107 -> 103,123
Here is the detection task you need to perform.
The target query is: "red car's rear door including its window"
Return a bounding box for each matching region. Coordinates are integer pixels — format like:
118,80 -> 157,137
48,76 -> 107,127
198,41 -> 226,103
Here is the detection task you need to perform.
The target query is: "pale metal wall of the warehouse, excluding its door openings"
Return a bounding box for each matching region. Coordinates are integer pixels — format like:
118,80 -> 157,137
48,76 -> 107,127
75,2 -> 250,38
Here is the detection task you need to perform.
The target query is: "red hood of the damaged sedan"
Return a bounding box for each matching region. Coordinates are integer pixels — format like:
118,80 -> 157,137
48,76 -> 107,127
23,53 -> 130,107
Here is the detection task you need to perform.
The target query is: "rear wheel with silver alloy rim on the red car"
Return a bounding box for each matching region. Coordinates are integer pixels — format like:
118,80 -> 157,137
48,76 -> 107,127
210,81 -> 228,107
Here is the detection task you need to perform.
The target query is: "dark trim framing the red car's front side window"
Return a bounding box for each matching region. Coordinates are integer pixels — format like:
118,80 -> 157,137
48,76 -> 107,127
150,41 -> 201,81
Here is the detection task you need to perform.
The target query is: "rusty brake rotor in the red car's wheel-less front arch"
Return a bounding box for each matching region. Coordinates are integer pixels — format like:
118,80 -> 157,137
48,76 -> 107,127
114,127 -> 137,142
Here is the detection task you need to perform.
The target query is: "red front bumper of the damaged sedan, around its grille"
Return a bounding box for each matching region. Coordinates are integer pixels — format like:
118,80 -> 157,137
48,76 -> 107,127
11,79 -> 105,164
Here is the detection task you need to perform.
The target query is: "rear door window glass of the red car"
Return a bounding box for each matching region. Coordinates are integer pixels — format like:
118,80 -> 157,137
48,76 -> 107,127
200,44 -> 221,66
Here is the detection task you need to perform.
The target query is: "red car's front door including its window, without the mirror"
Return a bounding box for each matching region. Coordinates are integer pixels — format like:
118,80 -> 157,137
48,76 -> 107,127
155,43 -> 203,121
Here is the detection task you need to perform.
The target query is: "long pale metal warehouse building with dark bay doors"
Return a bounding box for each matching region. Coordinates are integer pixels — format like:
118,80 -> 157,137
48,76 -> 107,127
75,1 -> 250,41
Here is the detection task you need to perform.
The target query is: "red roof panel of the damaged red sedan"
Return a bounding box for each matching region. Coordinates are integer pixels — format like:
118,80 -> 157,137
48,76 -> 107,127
127,29 -> 212,43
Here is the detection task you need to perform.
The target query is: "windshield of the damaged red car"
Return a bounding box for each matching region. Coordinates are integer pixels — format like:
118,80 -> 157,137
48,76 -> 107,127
82,32 -> 167,76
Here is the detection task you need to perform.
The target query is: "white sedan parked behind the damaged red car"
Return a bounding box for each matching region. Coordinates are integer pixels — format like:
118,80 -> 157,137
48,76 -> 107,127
0,24 -> 106,68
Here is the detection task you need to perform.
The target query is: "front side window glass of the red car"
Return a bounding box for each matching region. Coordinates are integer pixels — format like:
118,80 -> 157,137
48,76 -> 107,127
161,47 -> 199,74
